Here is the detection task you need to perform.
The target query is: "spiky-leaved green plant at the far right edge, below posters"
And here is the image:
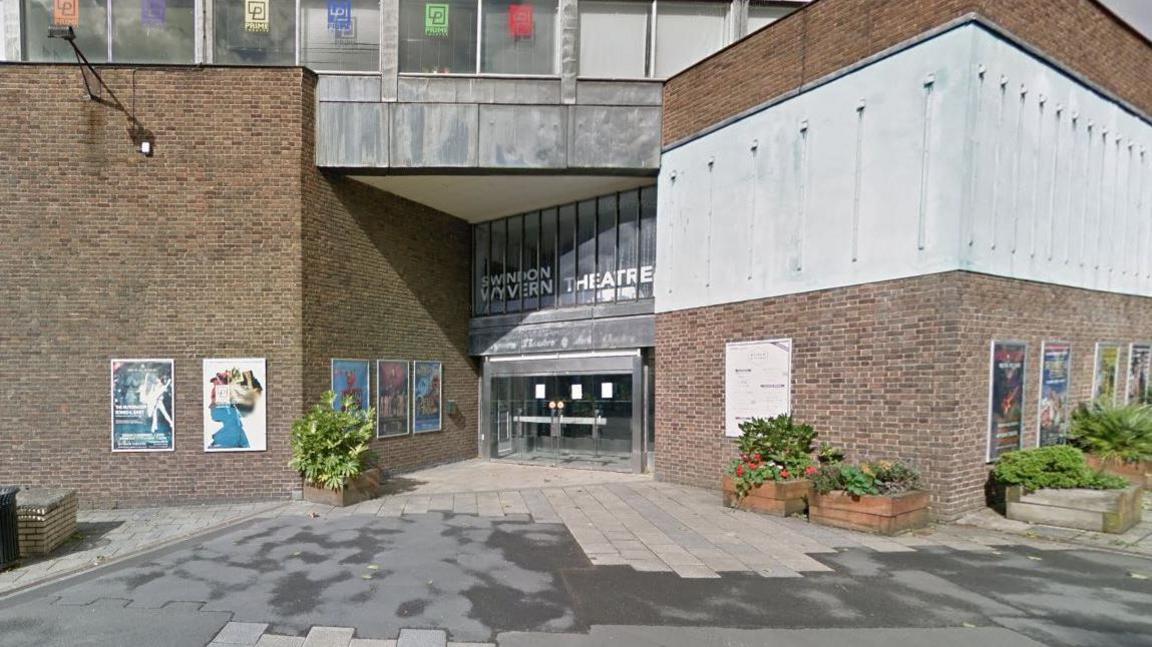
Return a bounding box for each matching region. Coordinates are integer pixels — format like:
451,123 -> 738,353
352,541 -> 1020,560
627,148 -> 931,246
1068,402 -> 1152,463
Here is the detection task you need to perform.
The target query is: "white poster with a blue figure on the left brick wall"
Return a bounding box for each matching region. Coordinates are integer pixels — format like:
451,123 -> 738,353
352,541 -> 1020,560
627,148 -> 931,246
203,358 -> 267,451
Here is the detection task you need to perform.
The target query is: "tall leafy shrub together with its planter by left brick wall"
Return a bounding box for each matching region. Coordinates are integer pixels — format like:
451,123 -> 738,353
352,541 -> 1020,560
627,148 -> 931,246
289,391 -> 380,505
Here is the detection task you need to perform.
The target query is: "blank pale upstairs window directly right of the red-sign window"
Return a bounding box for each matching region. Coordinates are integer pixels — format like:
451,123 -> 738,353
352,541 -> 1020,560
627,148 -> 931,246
579,0 -> 652,78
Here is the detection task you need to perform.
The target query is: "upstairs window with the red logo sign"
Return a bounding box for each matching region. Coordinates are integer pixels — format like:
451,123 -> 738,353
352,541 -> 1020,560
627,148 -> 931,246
480,0 -> 556,75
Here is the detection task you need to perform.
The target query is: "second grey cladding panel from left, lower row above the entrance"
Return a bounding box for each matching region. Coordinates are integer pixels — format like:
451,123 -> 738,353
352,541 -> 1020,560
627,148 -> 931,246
392,104 -> 478,167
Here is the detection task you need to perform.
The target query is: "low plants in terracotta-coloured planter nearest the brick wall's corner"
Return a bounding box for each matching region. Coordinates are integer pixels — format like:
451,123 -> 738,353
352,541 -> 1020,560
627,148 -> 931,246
808,460 -> 930,535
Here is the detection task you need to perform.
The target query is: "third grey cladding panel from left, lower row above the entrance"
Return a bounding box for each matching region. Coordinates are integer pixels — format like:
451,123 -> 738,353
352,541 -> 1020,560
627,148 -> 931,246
479,106 -> 568,169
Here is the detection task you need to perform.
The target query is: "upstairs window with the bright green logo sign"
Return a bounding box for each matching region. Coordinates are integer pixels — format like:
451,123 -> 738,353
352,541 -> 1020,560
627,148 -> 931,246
400,0 -> 477,74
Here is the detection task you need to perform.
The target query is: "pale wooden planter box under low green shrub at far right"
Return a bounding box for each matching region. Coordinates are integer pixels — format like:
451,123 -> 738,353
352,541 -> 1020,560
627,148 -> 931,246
1005,486 -> 1144,533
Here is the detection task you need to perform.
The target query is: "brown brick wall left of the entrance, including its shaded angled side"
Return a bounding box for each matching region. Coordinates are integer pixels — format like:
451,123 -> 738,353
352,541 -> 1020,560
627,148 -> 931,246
0,64 -> 476,507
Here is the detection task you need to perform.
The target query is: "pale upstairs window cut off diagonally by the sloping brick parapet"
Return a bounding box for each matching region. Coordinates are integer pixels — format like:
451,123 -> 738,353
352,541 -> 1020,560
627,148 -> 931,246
655,0 -> 728,77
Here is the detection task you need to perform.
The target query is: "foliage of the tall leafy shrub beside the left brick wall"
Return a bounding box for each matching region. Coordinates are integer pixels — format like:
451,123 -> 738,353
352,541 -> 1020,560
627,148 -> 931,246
289,391 -> 376,489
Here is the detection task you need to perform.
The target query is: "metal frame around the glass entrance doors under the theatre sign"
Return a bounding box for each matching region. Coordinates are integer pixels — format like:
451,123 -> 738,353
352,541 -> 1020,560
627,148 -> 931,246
479,349 -> 649,473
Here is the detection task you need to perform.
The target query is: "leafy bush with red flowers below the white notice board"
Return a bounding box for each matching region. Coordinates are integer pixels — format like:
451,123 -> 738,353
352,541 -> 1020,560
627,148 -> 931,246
726,414 -> 816,498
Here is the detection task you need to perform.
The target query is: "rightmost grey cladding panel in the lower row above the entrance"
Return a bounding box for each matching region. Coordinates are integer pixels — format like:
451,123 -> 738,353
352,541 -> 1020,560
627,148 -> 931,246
568,105 -> 660,169
